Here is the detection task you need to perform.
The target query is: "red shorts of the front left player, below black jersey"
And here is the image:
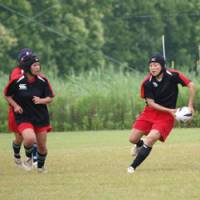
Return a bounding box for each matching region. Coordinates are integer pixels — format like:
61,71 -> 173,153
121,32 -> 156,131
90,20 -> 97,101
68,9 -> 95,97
17,122 -> 52,134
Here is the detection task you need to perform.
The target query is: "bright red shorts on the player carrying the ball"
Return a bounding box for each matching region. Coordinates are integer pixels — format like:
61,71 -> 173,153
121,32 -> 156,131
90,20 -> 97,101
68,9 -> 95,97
132,106 -> 175,142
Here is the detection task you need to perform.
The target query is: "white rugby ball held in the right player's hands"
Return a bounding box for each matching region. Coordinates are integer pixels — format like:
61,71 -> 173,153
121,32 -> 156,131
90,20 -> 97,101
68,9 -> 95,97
175,106 -> 192,122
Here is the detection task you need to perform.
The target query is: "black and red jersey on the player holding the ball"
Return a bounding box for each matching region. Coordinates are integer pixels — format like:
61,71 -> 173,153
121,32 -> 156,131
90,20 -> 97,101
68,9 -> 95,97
141,69 -> 190,108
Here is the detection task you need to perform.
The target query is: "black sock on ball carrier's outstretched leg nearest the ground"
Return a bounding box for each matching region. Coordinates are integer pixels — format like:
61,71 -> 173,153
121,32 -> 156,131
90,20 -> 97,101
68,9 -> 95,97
131,144 -> 152,169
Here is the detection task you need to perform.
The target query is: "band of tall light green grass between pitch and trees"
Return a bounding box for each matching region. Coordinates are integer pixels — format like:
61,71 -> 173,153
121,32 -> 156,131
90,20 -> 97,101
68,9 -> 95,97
0,68 -> 200,132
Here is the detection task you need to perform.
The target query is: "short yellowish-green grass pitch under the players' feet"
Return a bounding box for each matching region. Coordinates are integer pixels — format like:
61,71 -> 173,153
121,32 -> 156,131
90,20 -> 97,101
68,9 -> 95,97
0,129 -> 200,200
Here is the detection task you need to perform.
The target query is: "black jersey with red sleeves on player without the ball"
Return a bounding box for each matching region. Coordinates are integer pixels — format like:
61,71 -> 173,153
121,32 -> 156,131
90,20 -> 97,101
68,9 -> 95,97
4,75 -> 54,127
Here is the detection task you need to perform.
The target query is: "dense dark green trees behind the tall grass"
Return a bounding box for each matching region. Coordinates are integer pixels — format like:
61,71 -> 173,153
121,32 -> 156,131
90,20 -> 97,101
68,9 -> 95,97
0,0 -> 200,76
